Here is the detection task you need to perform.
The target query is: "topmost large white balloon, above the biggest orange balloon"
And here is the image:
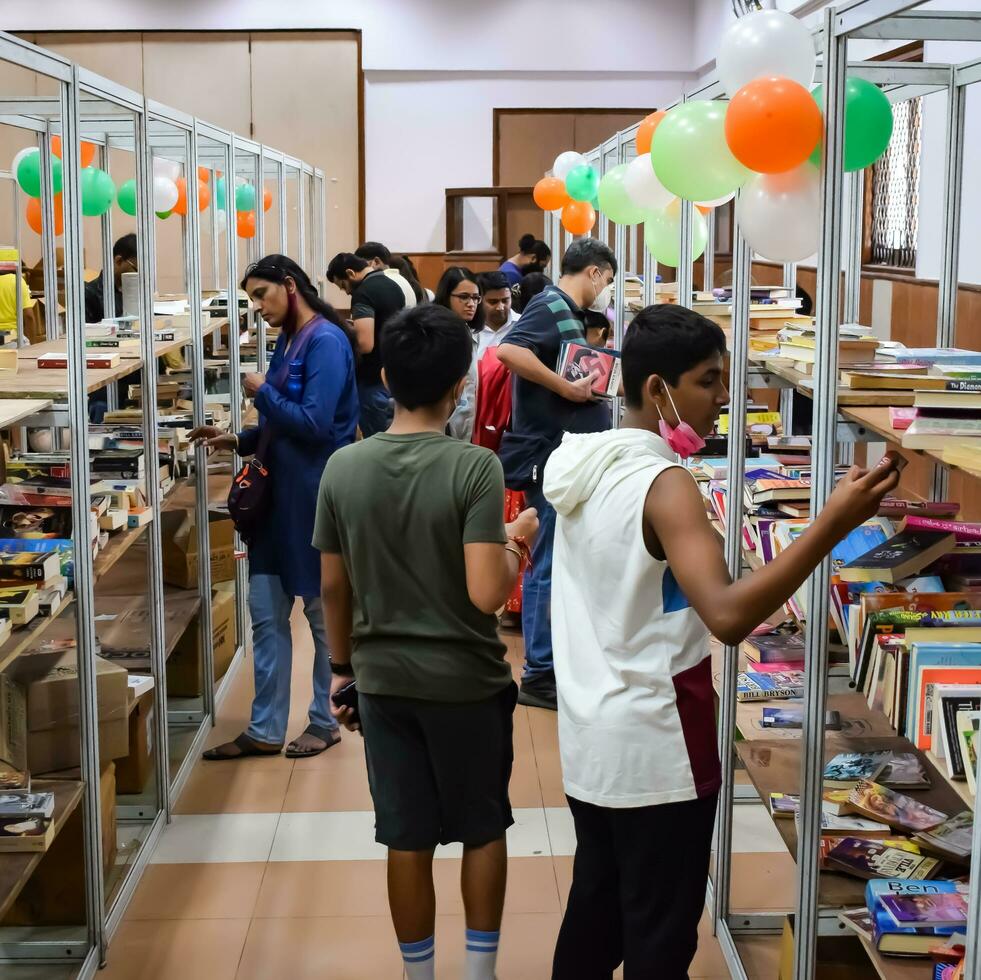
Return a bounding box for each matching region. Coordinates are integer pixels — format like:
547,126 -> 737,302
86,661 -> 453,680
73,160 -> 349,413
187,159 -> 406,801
715,10 -> 817,97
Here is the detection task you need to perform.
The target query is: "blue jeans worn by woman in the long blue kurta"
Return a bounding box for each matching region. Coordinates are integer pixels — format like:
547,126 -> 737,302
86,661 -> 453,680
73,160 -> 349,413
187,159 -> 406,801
246,575 -> 337,745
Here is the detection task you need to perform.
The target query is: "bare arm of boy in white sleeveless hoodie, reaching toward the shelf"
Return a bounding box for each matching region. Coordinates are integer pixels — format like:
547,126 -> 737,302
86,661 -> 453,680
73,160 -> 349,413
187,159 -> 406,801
644,457 -> 899,644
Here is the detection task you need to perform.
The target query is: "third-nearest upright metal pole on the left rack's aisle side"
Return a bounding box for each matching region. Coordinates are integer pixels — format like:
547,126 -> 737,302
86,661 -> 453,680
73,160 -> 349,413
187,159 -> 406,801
183,119 -> 213,720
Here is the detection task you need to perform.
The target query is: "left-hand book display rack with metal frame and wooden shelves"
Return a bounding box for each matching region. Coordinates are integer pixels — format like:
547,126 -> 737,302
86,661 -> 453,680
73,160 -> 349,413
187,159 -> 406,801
0,33 -> 326,977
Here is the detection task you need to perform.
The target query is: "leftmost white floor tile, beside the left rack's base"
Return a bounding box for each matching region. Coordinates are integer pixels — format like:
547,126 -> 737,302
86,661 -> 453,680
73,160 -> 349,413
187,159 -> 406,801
152,813 -> 280,864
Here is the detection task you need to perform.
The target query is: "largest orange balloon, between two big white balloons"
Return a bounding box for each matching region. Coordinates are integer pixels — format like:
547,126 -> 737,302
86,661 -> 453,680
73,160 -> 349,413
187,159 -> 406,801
726,78 -> 823,174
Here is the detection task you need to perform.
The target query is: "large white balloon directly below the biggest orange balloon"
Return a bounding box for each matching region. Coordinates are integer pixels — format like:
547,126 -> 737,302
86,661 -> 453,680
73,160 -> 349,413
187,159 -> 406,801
736,163 -> 821,262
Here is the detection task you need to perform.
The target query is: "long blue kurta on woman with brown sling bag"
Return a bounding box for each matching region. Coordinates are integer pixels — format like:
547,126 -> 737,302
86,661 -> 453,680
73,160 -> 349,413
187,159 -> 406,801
238,316 -> 358,596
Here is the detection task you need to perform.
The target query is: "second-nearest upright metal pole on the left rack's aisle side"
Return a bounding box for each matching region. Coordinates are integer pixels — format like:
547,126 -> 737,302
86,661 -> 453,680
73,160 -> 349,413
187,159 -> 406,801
134,103 -> 171,822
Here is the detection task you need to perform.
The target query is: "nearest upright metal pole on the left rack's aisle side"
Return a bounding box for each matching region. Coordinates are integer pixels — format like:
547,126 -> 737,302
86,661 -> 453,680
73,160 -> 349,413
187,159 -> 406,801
59,65 -> 107,961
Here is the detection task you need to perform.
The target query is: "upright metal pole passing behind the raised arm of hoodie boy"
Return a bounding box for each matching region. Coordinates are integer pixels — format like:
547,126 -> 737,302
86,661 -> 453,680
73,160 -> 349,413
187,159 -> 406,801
712,220 -> 753,936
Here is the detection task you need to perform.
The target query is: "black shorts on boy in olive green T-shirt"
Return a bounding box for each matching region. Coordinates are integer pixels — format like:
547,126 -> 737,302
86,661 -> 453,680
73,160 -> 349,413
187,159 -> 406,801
358,682 -> 518,851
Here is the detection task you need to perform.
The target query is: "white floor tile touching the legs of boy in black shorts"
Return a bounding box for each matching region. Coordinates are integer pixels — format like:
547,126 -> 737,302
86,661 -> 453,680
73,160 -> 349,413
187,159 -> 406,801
269,810 -> 386,861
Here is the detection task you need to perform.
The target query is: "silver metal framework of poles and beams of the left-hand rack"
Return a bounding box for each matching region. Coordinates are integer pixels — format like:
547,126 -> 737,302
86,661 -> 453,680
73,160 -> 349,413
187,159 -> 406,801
0,32 -> 326,978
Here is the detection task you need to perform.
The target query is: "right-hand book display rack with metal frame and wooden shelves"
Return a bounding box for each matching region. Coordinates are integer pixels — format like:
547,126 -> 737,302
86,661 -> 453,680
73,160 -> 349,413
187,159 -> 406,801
568,0 -> 981,980
